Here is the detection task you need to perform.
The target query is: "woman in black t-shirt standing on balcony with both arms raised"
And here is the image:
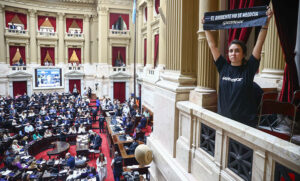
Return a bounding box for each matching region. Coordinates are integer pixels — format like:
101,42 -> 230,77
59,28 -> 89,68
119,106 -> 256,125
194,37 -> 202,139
202,9 -> 273,127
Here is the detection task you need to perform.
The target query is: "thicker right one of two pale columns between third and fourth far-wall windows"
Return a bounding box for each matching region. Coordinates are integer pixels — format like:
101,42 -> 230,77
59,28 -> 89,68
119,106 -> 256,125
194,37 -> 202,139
98,7 -> 111,65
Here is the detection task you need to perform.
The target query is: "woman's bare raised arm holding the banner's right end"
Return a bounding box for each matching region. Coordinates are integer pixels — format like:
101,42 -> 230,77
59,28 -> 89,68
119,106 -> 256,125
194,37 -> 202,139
252,8 -> 273,60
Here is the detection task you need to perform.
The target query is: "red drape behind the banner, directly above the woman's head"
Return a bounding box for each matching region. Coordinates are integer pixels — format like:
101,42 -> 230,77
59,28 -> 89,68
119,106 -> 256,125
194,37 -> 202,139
228,0 -> 255,46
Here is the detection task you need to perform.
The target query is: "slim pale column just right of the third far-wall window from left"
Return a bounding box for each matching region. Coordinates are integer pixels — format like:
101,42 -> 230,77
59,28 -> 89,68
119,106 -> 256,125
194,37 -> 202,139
82,15 -> 90,63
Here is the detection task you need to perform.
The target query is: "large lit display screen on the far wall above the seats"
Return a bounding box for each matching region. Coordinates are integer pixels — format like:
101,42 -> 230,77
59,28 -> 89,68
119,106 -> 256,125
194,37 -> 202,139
35,68 -> 62,88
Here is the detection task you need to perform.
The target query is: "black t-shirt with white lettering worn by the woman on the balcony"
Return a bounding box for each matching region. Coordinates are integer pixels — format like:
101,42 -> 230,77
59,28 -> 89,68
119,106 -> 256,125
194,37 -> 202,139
215,55 -> 259,123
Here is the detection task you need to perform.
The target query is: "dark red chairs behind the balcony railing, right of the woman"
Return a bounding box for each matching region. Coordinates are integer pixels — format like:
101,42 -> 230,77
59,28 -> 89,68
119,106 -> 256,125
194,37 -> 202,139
258,90 -> 300,145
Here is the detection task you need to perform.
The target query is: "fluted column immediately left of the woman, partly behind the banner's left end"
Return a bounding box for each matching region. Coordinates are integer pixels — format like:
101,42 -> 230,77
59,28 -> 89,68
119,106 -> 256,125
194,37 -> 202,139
190,0 -> 218,110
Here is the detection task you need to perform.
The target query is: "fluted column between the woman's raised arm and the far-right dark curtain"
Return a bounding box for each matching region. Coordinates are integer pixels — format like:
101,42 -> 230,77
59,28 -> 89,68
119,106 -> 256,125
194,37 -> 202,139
261,13 -> 285,79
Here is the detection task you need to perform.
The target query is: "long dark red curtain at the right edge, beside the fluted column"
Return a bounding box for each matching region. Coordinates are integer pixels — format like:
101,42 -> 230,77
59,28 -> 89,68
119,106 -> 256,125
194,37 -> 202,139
272,0 -> 299,102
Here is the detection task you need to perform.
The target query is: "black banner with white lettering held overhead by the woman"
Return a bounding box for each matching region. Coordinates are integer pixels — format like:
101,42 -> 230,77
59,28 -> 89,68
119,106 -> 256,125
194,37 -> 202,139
203,6 -> 268,30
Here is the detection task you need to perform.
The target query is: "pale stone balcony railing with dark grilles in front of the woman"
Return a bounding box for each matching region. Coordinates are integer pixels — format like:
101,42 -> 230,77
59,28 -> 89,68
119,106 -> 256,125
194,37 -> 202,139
175,101 -> 300,180
